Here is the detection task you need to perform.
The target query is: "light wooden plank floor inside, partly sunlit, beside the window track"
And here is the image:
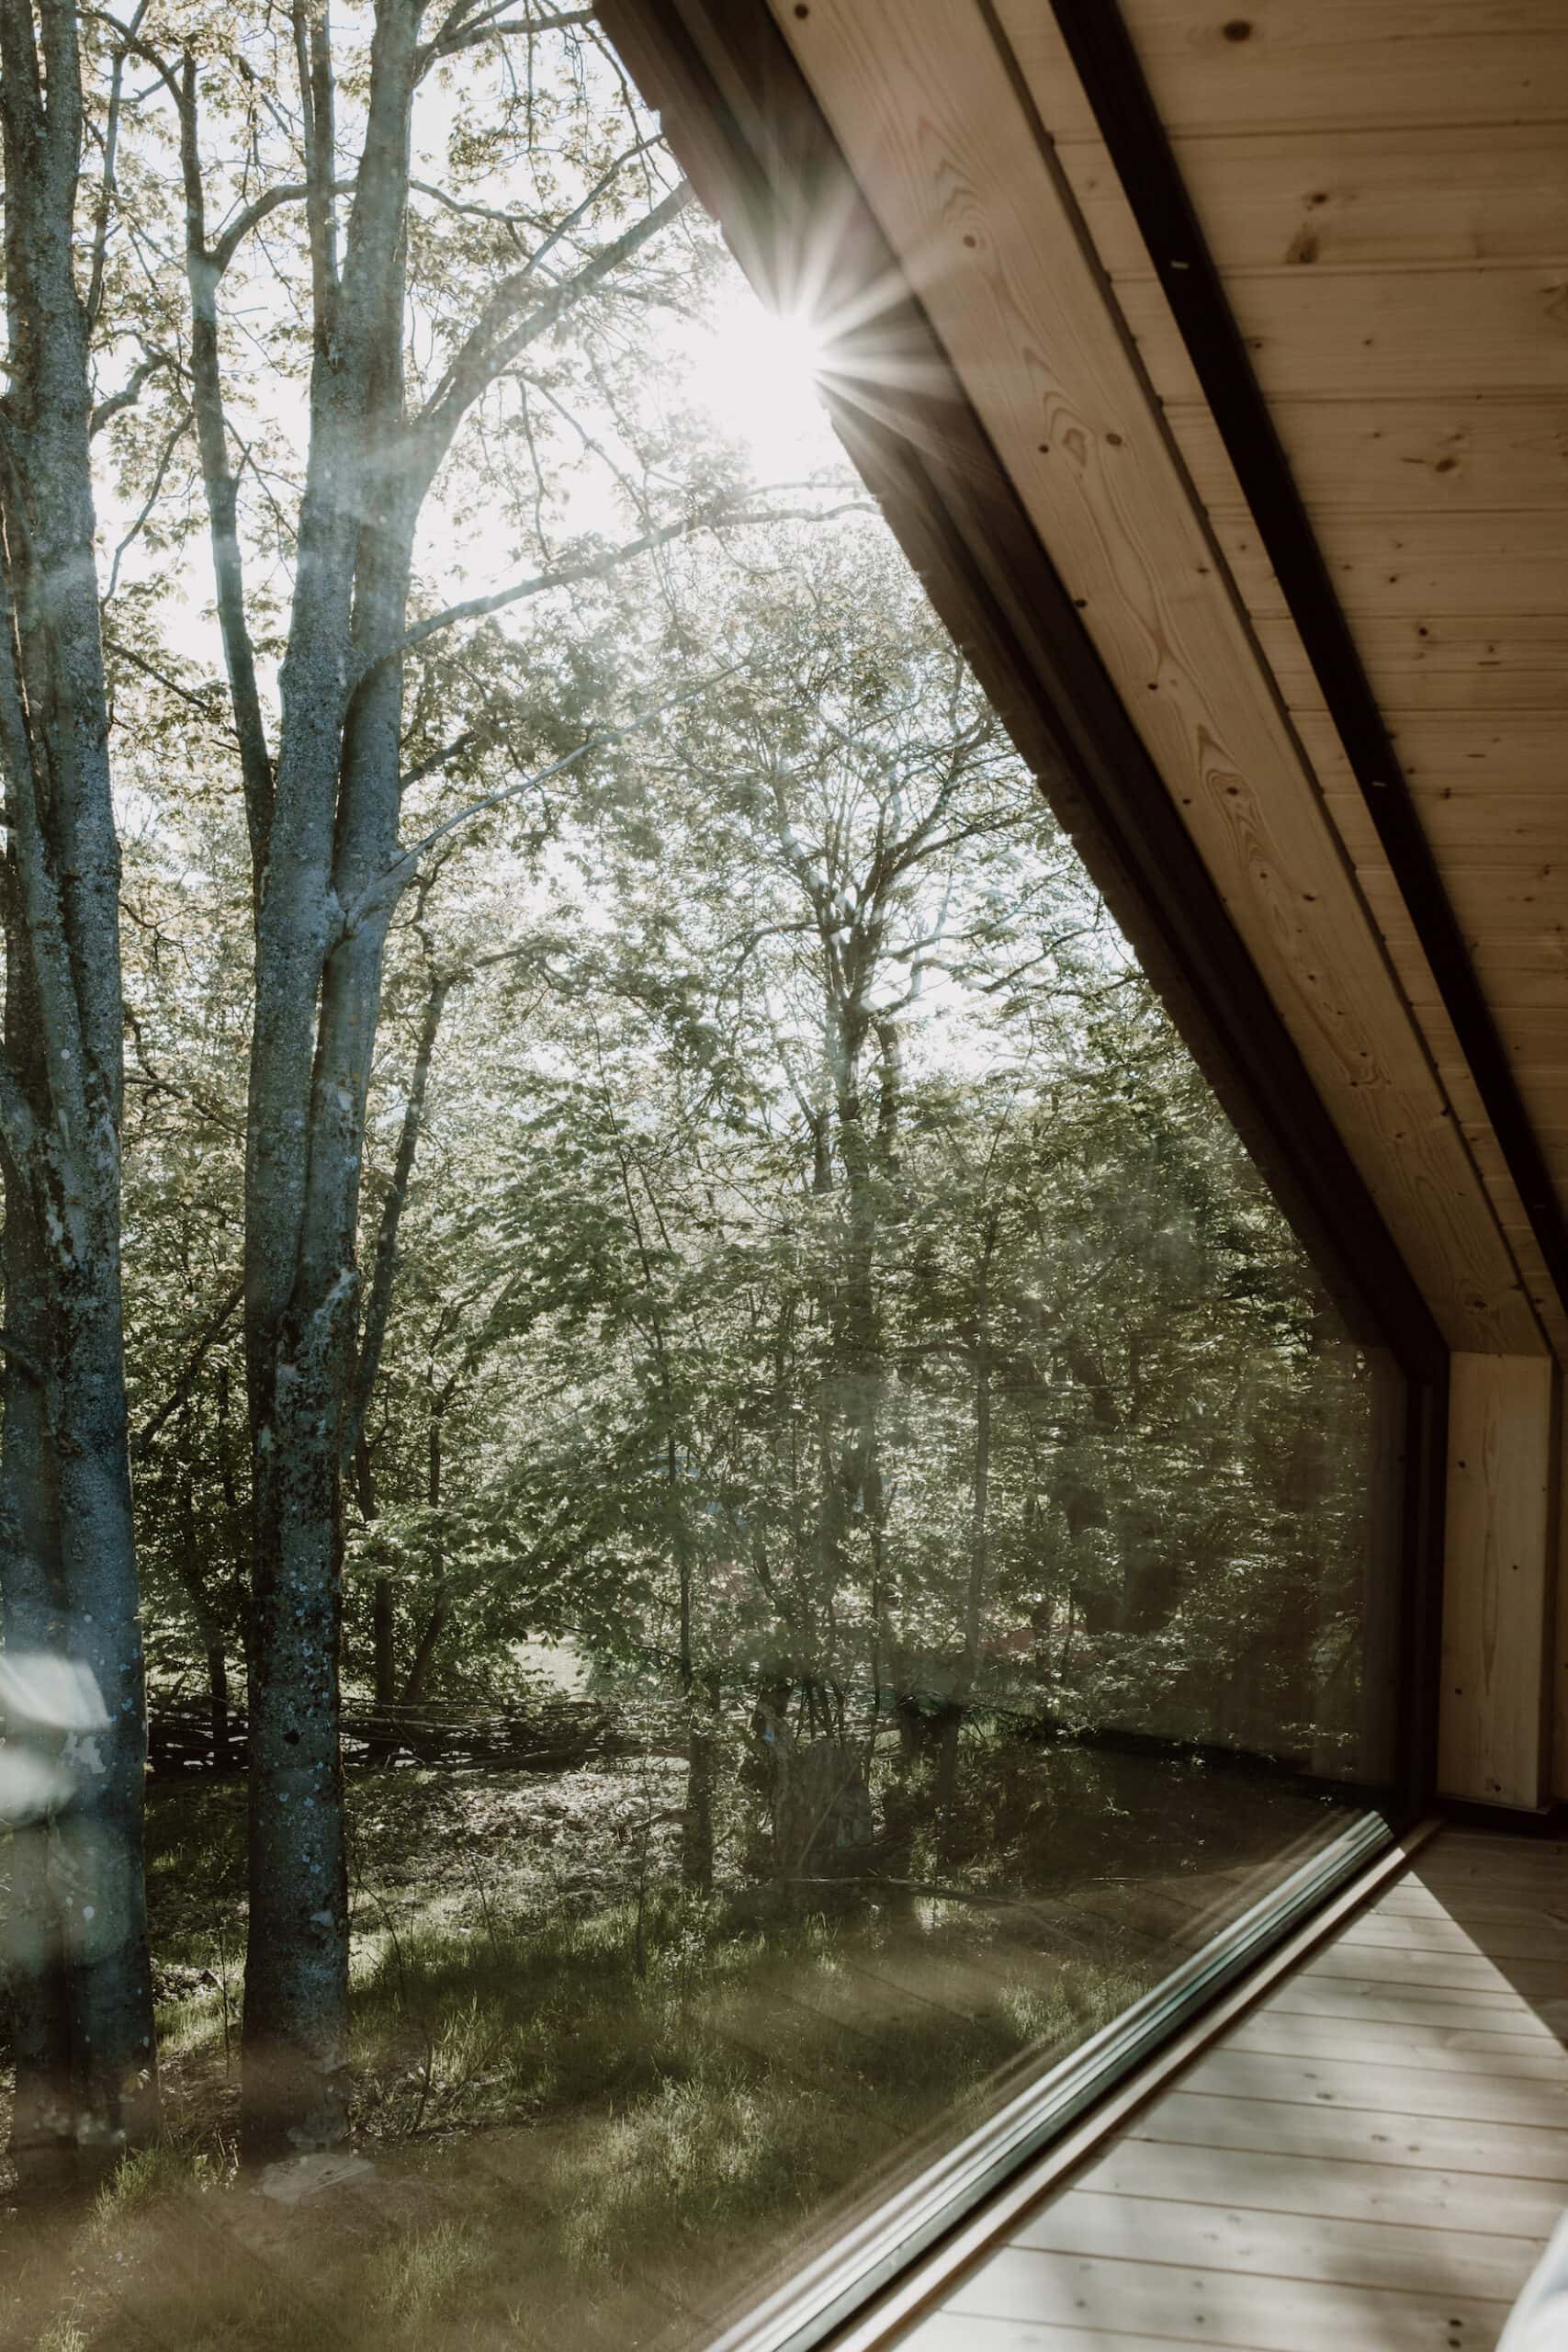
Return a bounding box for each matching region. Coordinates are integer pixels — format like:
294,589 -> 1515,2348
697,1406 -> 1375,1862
898,1830 -> 1568,2352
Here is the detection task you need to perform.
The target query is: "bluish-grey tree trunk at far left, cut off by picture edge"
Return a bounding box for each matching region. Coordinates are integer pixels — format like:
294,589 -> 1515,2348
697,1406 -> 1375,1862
0,0 -> 157,2178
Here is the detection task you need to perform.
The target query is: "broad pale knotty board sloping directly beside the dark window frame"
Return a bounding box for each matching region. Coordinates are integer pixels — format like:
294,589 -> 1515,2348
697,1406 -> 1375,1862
773,0 -> 1542,1352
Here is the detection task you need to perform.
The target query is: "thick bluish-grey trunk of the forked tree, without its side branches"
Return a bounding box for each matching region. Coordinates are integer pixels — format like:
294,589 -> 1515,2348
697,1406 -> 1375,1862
240,14 -> 419,2157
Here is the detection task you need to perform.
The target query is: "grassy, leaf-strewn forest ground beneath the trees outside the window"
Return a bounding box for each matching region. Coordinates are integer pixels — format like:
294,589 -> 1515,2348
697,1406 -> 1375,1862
0,1755 -> 1333,2352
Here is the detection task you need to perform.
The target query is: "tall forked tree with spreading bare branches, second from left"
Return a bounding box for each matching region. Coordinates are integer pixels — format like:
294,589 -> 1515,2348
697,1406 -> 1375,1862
88,0 -> 831,2150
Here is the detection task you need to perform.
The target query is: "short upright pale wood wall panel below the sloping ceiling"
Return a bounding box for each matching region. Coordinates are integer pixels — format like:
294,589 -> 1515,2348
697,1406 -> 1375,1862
1438,1355 -> 1561,1809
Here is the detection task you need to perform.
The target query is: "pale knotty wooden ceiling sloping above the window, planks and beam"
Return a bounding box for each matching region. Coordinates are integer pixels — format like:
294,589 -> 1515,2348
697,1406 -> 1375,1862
771,0 -> 1568,1360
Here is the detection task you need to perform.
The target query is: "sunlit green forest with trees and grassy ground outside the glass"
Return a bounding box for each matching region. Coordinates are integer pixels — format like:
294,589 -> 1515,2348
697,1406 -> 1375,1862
0,0 -> 1396,2352
